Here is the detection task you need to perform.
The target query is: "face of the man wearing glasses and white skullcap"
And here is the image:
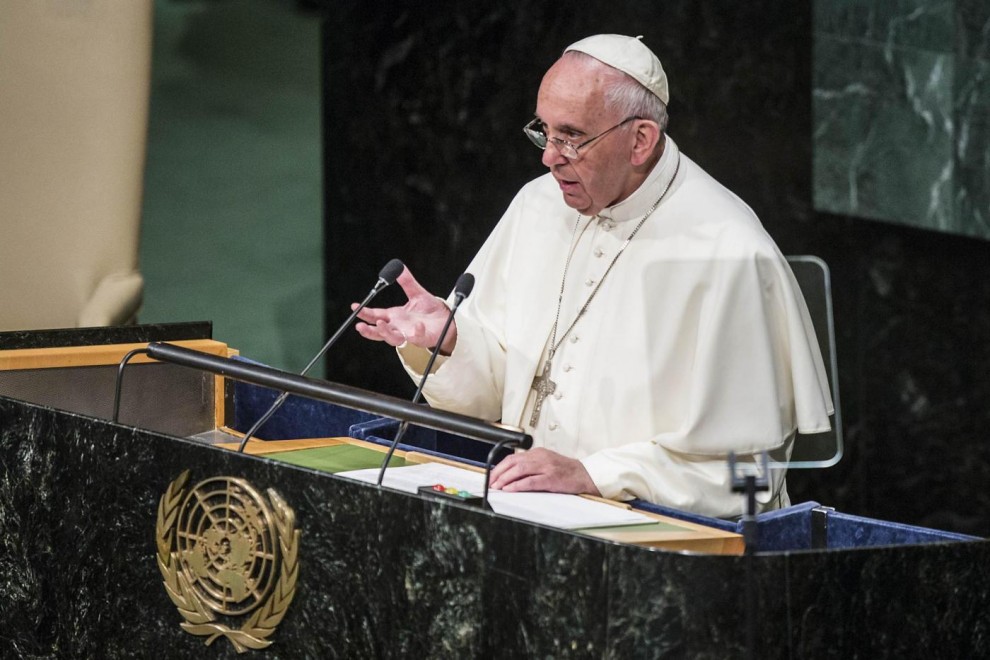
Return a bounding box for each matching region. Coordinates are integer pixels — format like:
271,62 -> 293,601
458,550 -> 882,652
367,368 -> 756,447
536,57 -> 638,215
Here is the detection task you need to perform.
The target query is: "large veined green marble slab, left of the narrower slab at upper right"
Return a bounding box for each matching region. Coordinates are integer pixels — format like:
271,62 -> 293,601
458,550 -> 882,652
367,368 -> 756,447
814,37 -> 956,231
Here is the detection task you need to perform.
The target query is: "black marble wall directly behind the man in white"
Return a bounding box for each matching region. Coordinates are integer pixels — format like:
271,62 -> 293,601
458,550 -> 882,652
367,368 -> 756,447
323,0 -> 990,535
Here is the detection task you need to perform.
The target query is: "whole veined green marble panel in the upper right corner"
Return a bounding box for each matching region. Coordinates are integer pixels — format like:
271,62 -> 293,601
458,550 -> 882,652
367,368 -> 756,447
813,0 -> 990,238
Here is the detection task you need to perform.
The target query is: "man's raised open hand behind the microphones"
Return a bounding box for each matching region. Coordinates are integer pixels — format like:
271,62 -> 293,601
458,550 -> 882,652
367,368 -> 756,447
351,268 -> 457,355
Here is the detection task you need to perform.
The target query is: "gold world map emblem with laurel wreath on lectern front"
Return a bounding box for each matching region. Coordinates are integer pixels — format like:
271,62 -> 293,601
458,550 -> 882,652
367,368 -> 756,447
155,470 -> 300,653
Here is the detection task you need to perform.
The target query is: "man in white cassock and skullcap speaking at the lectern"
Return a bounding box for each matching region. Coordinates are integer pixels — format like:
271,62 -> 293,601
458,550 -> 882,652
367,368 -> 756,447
357,35 -> 833,517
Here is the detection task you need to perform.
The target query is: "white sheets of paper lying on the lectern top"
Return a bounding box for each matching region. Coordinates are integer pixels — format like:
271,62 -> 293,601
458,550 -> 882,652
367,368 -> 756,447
338,463 -> 653,529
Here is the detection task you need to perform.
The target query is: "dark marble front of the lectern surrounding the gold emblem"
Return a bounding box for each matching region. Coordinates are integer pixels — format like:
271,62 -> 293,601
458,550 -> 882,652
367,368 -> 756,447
0,398 -> 990,658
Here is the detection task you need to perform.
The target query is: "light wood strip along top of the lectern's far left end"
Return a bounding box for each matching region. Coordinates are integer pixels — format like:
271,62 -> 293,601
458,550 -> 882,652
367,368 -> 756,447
0,339 -> 230,371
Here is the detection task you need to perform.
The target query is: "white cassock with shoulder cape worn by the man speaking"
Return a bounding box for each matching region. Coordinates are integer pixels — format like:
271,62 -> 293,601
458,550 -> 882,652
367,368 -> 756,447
399,137 -> 833,517
